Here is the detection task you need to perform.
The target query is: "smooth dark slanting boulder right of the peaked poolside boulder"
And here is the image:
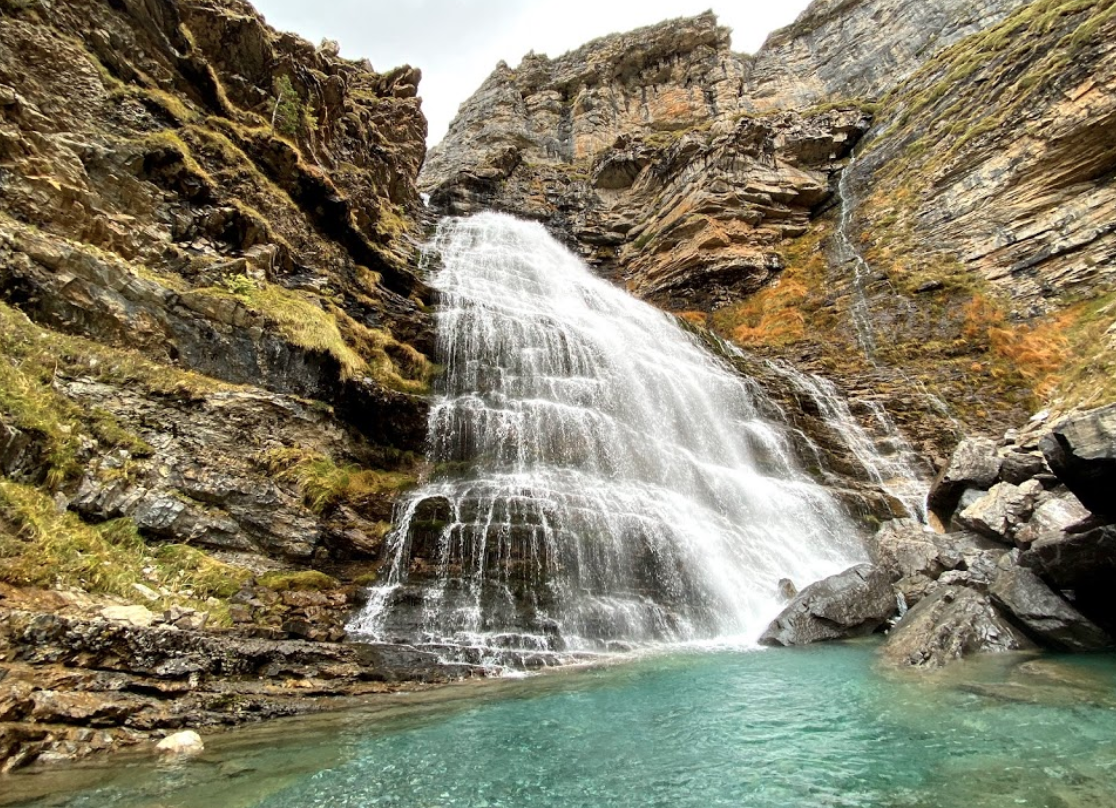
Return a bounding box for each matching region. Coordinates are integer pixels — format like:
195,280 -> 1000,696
990,567 -> 1112,651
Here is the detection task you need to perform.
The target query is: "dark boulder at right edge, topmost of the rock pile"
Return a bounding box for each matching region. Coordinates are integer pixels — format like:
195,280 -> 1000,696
1040,404 -> 1116,519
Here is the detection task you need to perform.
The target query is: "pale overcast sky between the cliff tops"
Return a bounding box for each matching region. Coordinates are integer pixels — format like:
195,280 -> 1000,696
252,0 -> 808,144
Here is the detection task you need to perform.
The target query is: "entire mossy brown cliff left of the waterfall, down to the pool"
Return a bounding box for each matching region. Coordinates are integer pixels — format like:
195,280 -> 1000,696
0,0 -> 454,766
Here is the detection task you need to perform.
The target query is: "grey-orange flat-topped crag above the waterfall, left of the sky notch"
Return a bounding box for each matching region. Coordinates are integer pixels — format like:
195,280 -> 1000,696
423,12 -> 743,186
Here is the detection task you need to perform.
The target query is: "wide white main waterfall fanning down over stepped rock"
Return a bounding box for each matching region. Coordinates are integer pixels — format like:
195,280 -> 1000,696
349,213 -> 864,652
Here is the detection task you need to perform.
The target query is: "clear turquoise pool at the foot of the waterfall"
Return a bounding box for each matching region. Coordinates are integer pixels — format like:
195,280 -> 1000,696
0,643 -> 1116,808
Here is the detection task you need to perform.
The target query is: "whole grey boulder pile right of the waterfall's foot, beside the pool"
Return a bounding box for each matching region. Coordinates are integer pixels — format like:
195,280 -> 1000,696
761,405 -> 1116,668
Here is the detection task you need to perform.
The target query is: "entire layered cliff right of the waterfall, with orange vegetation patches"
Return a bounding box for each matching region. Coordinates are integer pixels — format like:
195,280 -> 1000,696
421,0 -> 1116,441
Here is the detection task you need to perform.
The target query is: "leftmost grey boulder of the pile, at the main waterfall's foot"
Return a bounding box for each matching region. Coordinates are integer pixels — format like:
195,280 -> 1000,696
760,564 -> 897,645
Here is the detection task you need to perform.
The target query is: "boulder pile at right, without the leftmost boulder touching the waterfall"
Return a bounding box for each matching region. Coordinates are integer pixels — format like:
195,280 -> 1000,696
873,407 -> 1116,666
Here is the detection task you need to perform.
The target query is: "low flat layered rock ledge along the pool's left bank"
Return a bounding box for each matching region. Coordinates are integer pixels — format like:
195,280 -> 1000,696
0,588 -> 482,771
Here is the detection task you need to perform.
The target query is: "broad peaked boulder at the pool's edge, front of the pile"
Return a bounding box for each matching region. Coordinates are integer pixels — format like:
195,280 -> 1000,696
881,586 -> 1035,668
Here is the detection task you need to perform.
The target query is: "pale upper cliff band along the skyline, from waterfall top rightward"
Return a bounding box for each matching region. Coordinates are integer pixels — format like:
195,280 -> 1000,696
423,0 -> 1024,191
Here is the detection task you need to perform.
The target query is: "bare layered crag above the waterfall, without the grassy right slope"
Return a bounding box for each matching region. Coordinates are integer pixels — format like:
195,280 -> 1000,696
423,0 -> 1013,310
